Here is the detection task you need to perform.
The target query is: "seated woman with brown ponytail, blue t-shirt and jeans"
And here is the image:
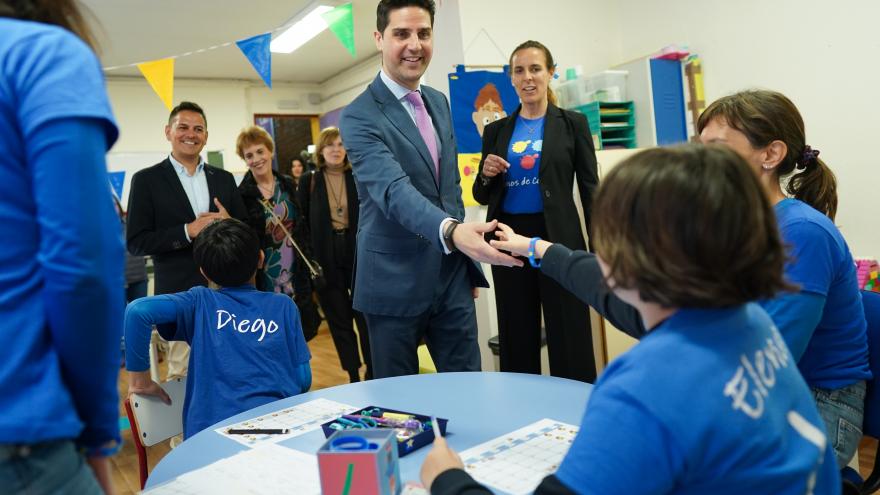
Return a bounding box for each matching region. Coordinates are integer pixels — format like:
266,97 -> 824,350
697,90 -> 871,467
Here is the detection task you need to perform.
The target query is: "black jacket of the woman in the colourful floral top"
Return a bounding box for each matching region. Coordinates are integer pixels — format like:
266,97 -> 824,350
238,170 -> 312,300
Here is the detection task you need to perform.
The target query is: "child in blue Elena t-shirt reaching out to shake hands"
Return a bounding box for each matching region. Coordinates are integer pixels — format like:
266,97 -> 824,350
421,146 -> 841,495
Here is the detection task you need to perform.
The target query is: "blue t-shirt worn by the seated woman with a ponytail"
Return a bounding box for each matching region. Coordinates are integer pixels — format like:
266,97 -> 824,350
762,199 -> 871,389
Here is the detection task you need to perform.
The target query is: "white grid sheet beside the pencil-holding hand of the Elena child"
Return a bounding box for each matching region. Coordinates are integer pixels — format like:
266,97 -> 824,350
461,419 -> 579,495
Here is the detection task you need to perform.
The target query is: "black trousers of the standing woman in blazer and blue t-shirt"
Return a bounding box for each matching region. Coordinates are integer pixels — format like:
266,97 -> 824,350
492,213 -> 596,383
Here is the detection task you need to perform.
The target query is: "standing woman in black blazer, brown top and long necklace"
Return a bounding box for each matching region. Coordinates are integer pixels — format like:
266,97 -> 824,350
297,127 -> 373,382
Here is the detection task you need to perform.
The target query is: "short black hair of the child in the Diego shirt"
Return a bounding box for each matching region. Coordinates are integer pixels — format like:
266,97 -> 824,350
193,218 -> 260,287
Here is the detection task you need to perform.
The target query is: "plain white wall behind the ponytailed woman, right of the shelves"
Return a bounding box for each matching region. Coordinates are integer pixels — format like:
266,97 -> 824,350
614,0 -> 880,257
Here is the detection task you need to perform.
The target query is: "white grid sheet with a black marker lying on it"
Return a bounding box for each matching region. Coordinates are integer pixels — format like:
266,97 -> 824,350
214,399 -> 361,447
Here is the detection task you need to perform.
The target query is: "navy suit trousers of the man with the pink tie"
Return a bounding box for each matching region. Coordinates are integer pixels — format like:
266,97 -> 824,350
365,255 -> 480,378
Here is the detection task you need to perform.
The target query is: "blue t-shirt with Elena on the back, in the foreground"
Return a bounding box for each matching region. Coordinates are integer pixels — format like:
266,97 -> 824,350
556,304 -> 840,495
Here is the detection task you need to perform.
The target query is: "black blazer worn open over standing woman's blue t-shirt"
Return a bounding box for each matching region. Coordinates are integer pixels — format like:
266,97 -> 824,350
473,104 -> 599,249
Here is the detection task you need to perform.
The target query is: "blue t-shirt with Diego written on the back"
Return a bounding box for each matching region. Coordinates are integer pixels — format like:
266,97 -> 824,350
157,285 -> 311,438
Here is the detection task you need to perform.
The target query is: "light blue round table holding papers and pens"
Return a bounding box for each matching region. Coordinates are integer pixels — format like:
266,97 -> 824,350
146,372 -> 592,488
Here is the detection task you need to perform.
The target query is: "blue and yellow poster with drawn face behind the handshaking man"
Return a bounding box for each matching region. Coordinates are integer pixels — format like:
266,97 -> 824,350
449,65 -> 519,206
